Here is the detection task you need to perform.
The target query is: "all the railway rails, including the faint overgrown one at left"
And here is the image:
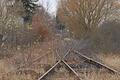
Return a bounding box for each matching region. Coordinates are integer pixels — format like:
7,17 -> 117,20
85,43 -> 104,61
11,49 -> 120,80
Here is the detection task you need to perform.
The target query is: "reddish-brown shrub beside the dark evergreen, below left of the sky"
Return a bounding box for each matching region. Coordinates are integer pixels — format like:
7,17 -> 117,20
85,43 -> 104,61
32,8 -> 51,40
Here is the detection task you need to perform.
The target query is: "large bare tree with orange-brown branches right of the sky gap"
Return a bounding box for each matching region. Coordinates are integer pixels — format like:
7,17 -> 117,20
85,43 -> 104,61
57,0 -> 113,37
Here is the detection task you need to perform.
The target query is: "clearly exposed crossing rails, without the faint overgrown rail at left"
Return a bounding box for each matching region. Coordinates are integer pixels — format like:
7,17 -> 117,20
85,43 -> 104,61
38,49 -> 120,80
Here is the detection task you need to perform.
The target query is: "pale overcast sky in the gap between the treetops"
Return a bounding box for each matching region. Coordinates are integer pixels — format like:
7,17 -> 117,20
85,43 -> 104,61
39,0 -> 57,15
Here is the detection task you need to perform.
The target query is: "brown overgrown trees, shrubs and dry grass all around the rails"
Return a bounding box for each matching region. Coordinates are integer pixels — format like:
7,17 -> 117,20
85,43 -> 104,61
0,0 -> 120,80
